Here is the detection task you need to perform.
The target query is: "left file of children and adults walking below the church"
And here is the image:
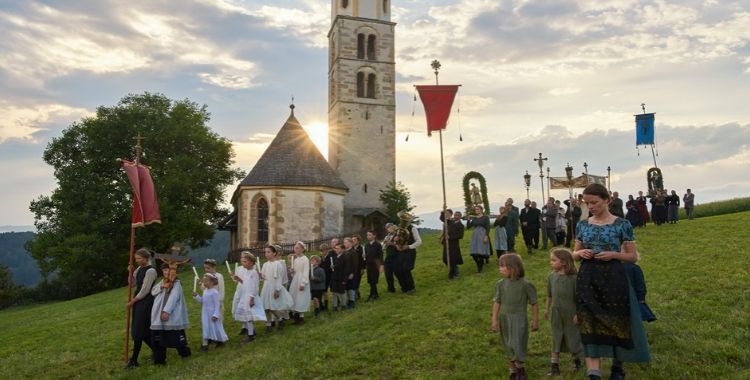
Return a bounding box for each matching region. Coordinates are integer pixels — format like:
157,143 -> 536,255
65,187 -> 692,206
126,218 -> 422,369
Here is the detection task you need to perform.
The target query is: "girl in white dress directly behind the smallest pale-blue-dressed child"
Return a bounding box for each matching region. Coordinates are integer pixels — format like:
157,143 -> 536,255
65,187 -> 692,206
230,251 -> 266,344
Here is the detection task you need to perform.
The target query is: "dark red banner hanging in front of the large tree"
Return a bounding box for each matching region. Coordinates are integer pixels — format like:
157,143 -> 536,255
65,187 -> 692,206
122,160 -> 161,227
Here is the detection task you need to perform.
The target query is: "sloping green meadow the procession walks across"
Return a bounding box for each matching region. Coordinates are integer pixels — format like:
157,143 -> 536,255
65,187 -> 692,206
0,212 -> 750,379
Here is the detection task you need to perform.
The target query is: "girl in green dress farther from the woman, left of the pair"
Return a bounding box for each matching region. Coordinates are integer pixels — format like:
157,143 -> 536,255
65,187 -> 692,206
492,254 -> 539,380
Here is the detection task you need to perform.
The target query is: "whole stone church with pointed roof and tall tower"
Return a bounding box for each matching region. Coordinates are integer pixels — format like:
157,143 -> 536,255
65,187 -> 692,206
219,0 -> 396,250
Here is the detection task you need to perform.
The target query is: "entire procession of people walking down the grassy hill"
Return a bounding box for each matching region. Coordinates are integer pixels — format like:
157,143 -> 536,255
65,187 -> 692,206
126,185 -> 680,380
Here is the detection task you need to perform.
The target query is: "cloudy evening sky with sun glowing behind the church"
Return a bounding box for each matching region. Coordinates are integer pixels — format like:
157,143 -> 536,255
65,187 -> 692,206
0,0 -> 750,226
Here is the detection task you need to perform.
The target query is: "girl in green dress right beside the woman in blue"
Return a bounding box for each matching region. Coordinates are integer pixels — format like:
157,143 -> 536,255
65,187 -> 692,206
544,248 -> 584,376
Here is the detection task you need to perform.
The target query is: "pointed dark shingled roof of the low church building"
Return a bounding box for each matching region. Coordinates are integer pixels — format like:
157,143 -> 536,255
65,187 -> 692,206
240,106 -> 348,190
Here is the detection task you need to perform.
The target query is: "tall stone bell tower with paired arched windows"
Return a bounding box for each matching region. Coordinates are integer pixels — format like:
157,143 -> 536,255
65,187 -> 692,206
328,0 -> 396,228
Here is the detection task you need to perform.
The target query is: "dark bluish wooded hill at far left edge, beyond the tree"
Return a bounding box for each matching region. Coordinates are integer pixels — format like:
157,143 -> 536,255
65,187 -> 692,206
0,232 -> 42,287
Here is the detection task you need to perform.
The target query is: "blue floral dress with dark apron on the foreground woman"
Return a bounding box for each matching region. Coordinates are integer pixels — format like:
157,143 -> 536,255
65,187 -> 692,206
576,218 -> 651,362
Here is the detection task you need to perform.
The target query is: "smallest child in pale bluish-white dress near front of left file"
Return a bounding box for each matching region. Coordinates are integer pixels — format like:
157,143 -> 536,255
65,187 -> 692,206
193,273 -> 229,351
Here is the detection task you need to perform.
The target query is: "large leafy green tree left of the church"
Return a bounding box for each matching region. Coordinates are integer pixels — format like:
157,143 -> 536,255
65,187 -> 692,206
28,93 -> 244,298
